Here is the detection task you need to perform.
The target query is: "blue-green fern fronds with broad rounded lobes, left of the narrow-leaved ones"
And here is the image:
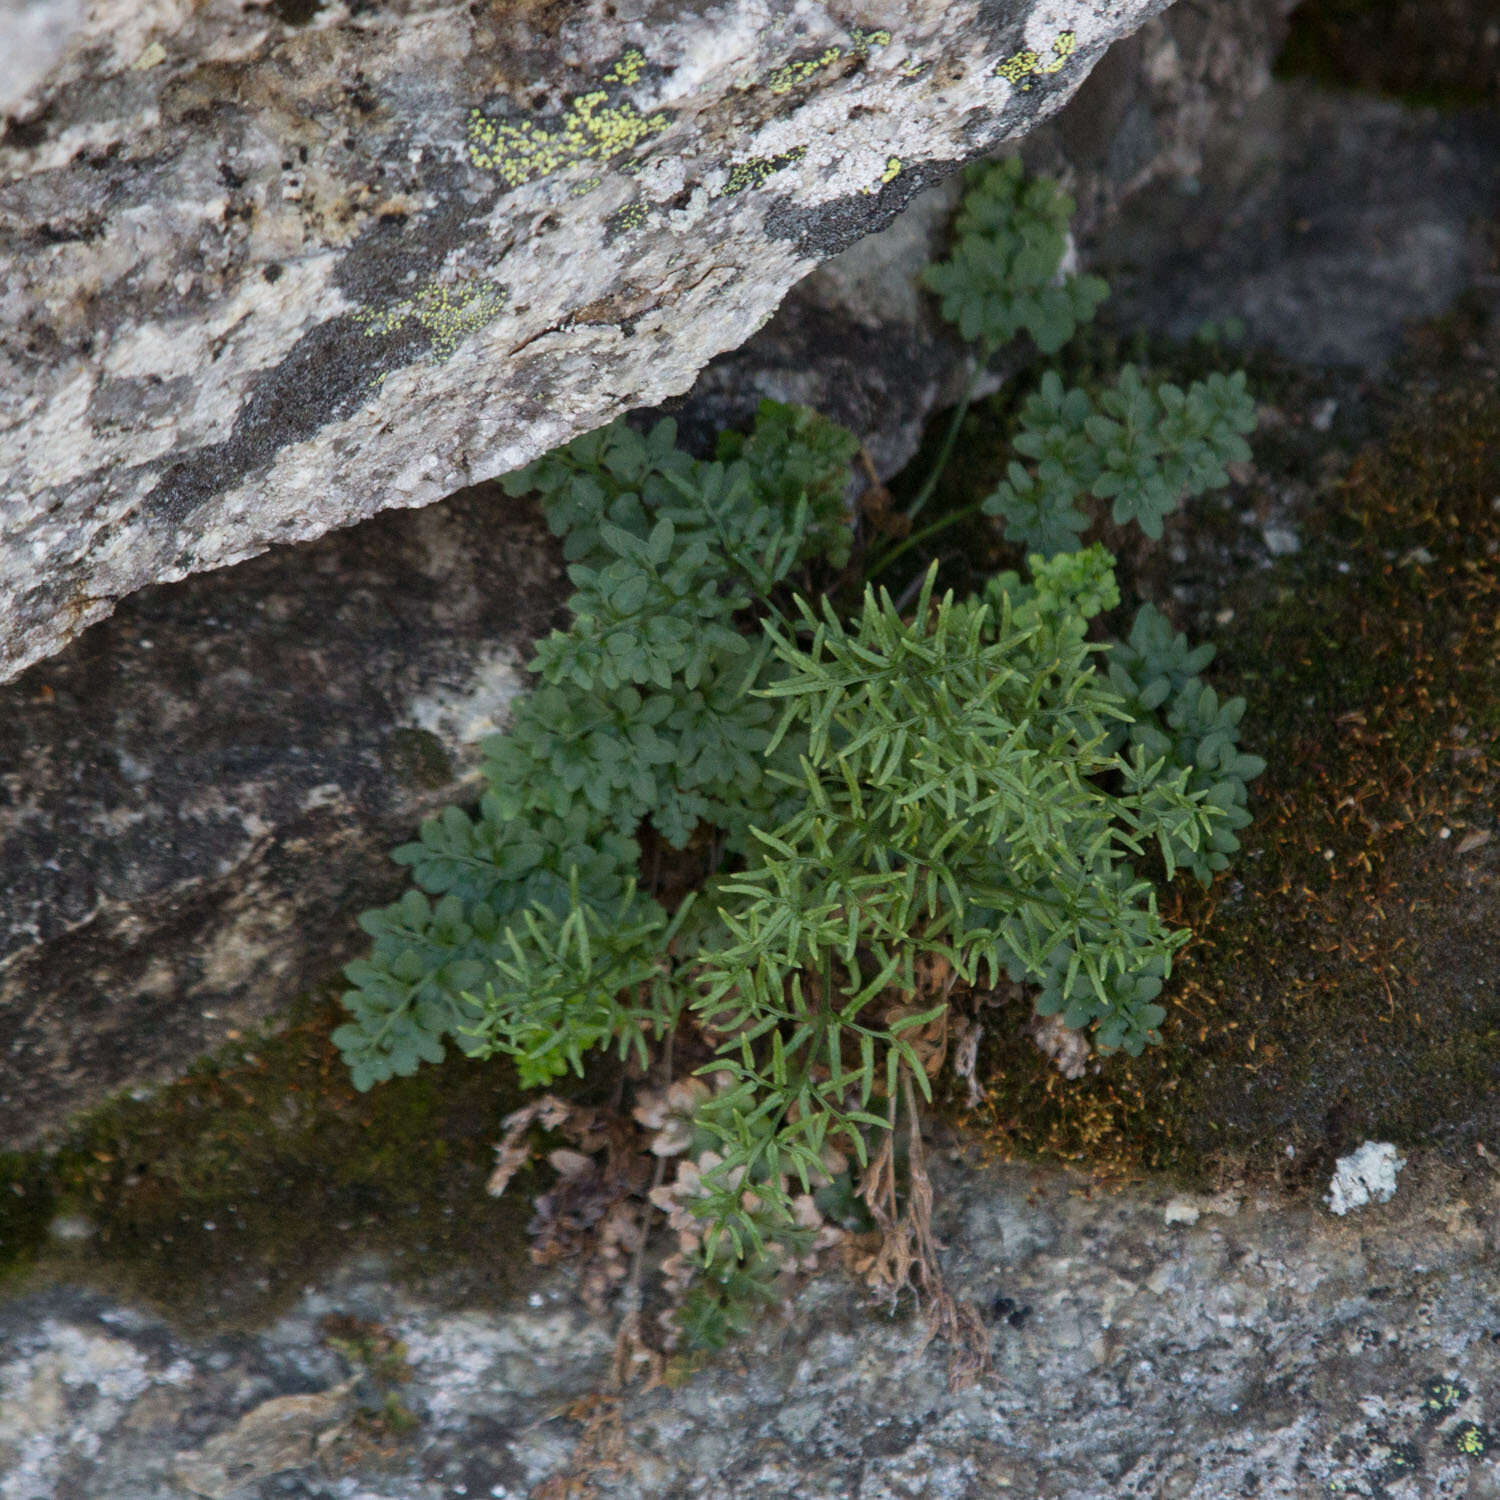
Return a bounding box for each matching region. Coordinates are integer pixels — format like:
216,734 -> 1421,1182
335,404 -> 854,1088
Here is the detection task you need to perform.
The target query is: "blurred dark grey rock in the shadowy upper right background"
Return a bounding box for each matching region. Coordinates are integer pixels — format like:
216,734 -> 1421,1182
1095,83 -> 1500,369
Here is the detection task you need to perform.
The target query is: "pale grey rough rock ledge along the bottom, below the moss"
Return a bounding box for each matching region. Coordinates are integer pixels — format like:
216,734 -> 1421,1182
0,1166 -> 1500,1500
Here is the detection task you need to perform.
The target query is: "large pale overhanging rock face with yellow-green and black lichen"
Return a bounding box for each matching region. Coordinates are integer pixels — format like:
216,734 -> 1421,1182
0,0 -> 1164,678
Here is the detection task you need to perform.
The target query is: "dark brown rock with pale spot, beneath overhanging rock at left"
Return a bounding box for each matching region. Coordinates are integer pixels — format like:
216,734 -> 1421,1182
0,486 -> 563,1145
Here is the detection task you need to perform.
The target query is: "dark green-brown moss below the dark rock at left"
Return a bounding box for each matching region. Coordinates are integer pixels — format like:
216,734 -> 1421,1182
0,995 -> 530,1325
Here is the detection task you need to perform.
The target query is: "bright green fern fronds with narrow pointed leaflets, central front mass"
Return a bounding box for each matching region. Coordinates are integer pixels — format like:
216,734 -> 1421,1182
675,551 -> 1220,1251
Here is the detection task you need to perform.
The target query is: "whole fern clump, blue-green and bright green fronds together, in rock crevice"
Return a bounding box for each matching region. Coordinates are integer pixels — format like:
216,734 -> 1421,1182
335,164 -> 1262,1346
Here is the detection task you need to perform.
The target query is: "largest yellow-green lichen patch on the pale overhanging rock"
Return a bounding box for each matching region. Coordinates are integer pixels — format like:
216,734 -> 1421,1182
468,48 -> 672,188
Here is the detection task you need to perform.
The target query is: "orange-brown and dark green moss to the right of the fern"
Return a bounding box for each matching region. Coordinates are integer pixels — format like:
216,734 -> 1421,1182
948,384 -> 1500,1184
